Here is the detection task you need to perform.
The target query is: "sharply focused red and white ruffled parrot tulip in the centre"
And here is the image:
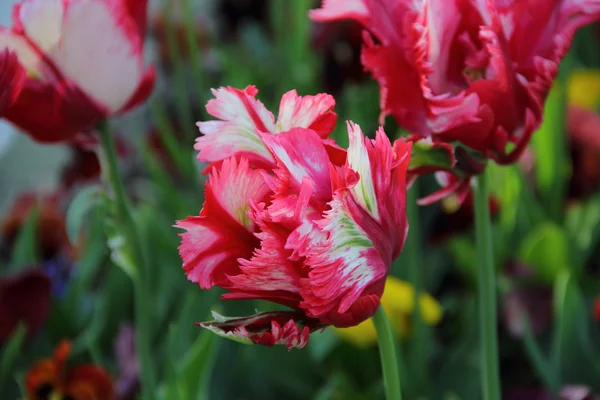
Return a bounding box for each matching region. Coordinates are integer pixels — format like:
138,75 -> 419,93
177,88 -> 411,349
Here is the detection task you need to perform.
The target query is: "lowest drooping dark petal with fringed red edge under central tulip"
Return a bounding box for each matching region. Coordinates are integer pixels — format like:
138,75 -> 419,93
197,311 -> 324,351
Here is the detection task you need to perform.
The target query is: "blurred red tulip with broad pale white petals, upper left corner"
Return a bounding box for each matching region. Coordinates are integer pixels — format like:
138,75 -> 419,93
0,0 -> 155,142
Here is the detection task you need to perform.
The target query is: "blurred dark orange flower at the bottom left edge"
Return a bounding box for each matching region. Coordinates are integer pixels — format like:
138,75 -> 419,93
25,341 -> 115,400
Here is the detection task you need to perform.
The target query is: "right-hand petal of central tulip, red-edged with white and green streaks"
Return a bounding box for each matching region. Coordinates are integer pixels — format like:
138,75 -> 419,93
300,123 -> 411,326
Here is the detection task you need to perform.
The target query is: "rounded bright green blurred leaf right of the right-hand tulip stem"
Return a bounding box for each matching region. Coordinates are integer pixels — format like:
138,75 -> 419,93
519,222 -> 571,282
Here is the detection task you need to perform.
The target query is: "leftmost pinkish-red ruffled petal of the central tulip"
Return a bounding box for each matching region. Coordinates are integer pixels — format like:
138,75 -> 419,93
176,158 -> 269,289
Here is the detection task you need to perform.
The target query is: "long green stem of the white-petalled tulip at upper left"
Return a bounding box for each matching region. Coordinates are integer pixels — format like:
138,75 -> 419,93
100,122 -> 156,400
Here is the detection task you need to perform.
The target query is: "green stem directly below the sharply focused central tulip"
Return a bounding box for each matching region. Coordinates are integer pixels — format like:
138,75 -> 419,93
372,306 -> 402,400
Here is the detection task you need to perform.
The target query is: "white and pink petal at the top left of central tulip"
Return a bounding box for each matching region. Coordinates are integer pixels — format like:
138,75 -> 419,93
194,86 -> 275,166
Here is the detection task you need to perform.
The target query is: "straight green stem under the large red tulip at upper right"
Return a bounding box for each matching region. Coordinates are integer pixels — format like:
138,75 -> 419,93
474,172 -> 500,400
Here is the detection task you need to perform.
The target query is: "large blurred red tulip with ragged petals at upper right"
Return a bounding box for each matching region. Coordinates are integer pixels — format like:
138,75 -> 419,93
310,0 -> 600,164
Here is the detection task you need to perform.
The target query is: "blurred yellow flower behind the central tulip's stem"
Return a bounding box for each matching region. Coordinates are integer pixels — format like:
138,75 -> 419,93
333,276 -> 444,347
